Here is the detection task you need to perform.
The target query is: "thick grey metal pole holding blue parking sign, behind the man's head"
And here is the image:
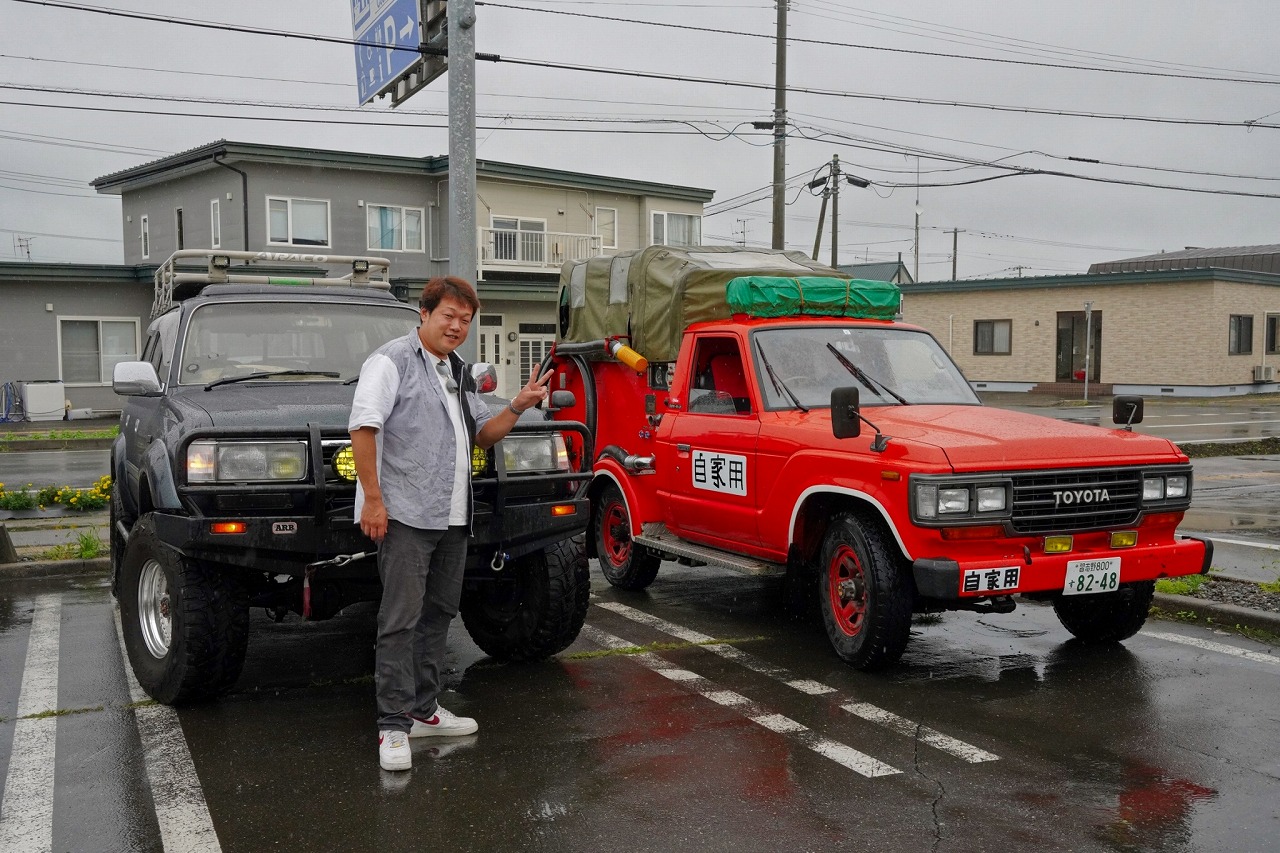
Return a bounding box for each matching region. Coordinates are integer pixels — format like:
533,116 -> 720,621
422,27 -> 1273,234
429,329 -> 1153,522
448,0 -> 480,361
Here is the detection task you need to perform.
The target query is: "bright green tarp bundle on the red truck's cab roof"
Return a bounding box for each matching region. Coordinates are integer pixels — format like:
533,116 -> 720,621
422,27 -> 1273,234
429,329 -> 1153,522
726,275 -> 901,320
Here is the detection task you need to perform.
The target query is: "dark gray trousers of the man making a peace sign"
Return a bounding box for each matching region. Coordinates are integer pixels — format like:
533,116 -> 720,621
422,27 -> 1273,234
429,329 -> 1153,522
375,520 -> 467,731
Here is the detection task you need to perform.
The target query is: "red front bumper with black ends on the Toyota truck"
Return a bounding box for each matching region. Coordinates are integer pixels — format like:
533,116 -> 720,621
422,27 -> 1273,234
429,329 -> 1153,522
911,535 -> 1213,601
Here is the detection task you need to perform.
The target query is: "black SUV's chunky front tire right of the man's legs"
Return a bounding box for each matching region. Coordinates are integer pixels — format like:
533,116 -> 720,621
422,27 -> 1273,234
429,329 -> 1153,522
460,538 -> 591,661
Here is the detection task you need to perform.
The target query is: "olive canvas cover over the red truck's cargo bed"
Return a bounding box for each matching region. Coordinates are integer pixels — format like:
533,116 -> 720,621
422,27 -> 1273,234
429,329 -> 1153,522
561,246 -> 865,361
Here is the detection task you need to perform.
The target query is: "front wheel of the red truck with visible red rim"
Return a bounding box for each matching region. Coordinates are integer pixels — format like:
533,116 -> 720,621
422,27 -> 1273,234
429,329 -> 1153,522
818,512 -> 914,670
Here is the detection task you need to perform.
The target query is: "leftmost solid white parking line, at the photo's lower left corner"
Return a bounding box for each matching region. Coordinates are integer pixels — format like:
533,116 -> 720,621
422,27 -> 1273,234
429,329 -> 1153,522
0,596 -> 63,853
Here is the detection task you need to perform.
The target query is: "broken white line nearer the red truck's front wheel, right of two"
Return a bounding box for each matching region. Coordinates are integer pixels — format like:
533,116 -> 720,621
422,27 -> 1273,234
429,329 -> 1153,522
595,601 -> 1000,763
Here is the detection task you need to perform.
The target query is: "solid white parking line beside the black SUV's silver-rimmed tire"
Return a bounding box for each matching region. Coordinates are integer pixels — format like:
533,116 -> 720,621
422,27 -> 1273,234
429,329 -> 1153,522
114,608 -> 223,853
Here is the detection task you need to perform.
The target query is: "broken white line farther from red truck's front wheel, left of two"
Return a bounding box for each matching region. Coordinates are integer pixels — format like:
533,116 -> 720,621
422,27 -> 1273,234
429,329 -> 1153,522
582,625 -> 902,779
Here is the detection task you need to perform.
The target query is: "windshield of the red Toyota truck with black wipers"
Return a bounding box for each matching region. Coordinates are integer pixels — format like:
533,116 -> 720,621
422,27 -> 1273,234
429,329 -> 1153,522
751,325 -> 979,409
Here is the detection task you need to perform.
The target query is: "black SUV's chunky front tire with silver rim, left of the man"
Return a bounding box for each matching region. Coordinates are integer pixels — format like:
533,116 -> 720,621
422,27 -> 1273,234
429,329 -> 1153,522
119,516 -> 248,704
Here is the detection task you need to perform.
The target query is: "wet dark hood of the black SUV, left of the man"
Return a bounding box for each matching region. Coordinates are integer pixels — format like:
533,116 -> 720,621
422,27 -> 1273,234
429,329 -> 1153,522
173,380 -> 356,428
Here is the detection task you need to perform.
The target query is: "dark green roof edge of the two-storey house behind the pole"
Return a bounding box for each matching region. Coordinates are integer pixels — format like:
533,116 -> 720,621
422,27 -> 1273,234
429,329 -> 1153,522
91,140 -> 716,204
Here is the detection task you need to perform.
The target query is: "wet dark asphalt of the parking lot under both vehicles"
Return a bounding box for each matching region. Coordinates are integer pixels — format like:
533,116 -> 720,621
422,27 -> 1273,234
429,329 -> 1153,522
0,564 -> 1280,853
